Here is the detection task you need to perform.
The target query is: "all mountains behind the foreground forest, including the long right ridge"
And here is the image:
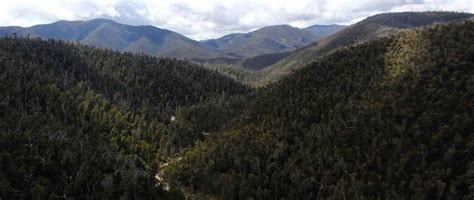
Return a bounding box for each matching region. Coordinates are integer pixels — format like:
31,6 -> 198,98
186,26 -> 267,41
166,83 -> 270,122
0,12 -> 466,79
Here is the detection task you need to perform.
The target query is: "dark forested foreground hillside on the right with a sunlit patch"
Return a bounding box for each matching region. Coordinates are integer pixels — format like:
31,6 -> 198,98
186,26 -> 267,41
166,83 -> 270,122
165,22 -> 474,199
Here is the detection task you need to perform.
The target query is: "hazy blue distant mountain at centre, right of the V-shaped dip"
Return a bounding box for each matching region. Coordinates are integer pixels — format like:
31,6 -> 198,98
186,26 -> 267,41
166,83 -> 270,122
202,25 -> 343,57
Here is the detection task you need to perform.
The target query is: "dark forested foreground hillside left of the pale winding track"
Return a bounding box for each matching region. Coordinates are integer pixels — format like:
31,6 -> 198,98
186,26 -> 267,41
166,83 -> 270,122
0,37 -> 249,199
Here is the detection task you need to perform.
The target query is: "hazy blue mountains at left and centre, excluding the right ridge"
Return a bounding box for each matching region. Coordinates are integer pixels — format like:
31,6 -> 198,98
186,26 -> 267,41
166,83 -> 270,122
0,19 -> 343,59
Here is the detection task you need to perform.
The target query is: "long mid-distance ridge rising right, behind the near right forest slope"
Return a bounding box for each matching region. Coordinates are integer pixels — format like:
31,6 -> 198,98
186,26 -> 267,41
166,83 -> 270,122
257,12 -> 473,85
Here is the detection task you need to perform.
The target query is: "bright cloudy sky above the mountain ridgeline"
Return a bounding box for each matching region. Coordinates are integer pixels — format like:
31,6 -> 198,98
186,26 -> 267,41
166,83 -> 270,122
0,0 -> 474,40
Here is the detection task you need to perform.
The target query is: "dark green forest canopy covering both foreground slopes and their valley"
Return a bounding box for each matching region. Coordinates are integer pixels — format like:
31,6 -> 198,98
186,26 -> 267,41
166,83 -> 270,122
0,13 -> 474,199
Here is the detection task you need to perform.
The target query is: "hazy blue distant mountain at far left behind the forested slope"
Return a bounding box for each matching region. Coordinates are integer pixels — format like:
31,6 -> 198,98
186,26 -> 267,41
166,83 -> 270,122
0,19 -> 225,58
